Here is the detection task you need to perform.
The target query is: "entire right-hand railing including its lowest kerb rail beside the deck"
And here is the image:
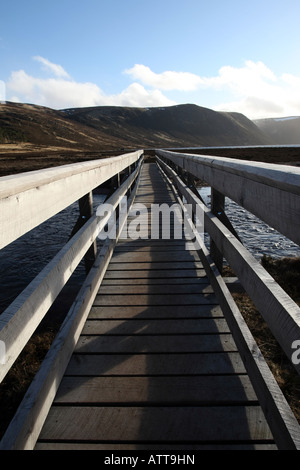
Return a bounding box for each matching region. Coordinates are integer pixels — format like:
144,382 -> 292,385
157,151 -> 300,449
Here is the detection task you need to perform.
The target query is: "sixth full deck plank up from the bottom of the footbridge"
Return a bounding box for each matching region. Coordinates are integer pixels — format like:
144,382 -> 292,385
89,305 -> 223,319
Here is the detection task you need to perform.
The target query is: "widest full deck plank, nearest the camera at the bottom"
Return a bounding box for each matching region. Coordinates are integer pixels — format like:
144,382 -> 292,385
40,406 -> 272,443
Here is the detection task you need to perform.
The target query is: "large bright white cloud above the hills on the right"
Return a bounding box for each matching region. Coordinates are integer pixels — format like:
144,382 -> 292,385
125,60 -> 300,119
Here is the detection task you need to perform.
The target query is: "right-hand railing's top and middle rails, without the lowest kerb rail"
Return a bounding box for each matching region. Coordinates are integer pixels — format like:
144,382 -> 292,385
157,150 -> 300,373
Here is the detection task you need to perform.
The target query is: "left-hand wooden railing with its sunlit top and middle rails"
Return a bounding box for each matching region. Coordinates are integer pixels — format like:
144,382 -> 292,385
0,151 -> 143,382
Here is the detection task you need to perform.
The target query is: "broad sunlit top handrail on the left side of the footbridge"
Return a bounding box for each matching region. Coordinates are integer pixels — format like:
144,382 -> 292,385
0,150 -> 143,249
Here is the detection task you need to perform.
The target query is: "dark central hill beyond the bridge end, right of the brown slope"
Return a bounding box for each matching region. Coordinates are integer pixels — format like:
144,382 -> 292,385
64,104 -> 272,148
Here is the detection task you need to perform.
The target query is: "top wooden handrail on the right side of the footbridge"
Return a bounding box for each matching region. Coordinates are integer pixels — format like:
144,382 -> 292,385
156,150 -> 300,244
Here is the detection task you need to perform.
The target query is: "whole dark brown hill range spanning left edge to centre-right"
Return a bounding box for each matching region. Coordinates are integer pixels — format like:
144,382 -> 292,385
0,102 -> 273,151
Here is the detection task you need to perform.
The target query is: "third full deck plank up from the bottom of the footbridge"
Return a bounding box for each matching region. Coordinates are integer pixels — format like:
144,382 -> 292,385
65,351 -> 246,376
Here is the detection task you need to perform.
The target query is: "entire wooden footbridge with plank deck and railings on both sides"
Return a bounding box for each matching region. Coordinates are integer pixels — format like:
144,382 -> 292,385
0,150 -> 300,452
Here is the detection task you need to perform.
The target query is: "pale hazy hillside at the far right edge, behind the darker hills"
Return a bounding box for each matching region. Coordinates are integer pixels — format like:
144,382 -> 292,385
253,116 -> 300,145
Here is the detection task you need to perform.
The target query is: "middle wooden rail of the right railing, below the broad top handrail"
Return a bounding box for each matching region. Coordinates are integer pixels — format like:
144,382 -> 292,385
157,156 -> 300,374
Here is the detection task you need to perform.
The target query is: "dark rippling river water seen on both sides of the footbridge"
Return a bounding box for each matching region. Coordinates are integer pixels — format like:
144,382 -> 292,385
0,188 -> 300,313
